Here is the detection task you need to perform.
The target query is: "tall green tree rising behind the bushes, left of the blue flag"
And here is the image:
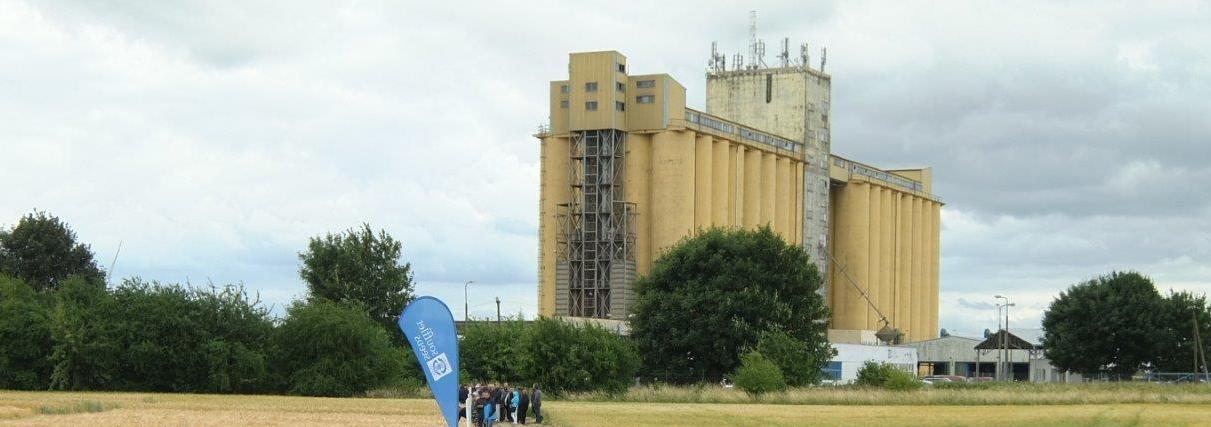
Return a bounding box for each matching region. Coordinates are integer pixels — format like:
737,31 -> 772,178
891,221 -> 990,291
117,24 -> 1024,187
299,224 -> 413,342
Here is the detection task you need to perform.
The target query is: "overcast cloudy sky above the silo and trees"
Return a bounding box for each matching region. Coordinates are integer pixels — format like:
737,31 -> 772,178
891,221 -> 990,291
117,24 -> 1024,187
0,0 -> 1211,334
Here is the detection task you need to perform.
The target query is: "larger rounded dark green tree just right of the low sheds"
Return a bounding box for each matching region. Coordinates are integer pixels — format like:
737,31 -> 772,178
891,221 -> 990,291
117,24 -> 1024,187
1043,272 -> 1164,379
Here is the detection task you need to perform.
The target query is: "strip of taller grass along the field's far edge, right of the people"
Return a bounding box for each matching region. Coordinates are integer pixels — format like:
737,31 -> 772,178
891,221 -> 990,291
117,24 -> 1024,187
561,382 -> 1211,405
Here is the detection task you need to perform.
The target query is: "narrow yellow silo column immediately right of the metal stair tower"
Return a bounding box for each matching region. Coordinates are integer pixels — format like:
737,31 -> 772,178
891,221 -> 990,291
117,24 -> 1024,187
625,133 -> 652,276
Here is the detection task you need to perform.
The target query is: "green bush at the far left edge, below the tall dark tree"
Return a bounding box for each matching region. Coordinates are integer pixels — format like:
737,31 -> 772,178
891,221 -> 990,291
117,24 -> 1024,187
0,275 -> 52,390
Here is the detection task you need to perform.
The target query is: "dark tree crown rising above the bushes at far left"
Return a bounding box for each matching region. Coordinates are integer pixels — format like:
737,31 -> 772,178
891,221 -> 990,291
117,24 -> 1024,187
0,210 -> 104,292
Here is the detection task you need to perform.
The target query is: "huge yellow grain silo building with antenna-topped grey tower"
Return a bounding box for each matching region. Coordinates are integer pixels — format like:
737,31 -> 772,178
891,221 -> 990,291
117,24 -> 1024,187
536,47 -> 941,341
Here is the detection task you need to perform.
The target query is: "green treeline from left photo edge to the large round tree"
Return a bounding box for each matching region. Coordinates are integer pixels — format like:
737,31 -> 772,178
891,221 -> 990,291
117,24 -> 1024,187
0,212 -> 638,396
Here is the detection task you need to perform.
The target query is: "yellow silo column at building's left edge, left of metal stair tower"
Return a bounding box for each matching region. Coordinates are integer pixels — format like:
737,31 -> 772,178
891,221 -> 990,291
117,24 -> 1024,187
538,137 -> 572,316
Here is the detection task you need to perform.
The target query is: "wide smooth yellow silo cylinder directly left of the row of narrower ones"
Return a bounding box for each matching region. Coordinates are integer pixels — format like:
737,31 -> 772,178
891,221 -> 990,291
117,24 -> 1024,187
650,131 -> 695,258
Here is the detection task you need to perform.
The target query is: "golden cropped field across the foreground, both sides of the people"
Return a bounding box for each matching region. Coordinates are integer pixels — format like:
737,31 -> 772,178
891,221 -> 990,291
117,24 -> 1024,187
0,390 -> 1211,427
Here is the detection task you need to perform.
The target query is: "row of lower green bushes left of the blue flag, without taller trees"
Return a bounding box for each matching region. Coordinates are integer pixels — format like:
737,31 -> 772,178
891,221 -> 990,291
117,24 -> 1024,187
0,276 -> 419,396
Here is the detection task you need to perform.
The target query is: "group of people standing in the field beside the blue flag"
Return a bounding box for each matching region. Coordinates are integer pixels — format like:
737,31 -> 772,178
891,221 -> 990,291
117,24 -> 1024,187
458,382 -> 543,427
